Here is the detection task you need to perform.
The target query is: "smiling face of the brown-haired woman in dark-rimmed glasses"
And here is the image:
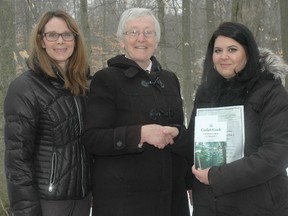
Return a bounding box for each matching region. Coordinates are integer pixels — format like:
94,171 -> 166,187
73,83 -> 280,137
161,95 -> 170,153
41,17 -> 75,71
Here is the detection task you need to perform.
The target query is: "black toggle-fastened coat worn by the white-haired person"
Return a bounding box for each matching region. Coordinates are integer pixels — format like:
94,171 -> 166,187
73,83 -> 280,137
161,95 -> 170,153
83,56 -> 189,216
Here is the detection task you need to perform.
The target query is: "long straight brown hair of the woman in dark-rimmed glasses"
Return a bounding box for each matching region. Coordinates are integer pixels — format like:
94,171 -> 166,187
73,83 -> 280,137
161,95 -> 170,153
28,10 -> 88,95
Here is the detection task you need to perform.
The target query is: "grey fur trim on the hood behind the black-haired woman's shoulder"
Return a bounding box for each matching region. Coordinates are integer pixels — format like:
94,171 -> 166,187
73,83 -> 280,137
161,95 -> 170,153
259,48 -> 288,79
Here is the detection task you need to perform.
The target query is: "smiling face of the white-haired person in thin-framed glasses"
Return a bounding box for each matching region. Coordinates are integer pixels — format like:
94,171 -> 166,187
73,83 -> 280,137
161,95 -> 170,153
120,16 -> 158,69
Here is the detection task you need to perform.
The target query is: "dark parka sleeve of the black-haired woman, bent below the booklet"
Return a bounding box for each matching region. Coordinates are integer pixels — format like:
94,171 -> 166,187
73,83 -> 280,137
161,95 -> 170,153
209,85 -> 288,196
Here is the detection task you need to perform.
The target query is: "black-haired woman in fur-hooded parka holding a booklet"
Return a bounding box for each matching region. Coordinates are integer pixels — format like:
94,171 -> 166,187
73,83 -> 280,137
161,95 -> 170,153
187,22 -> 288,216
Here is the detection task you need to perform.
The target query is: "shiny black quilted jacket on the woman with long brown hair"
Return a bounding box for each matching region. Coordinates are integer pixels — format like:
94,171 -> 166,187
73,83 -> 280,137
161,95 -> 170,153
4,70 -> 91,216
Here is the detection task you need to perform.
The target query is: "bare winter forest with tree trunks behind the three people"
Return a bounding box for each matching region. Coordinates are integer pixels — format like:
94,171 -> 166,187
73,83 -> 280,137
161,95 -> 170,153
0,0 -> 288,216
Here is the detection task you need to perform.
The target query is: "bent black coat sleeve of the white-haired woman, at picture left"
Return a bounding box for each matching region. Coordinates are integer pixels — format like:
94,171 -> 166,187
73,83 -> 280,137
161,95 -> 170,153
82,70 -> 143,156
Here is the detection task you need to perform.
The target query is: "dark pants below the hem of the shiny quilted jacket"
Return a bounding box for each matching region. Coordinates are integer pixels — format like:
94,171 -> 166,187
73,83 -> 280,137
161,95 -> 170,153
41,194 -> 92,216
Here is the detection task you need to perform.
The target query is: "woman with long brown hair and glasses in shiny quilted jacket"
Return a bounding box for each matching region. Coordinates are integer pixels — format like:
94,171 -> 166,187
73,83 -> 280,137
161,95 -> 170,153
4,10 -> 91,216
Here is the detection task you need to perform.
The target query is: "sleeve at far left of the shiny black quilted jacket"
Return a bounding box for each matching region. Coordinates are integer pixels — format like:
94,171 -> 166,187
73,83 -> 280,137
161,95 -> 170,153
4,78 -> 42,216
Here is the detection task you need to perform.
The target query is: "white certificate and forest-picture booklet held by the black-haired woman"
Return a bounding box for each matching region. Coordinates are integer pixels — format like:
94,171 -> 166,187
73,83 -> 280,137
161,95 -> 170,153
194,105 -> 245,168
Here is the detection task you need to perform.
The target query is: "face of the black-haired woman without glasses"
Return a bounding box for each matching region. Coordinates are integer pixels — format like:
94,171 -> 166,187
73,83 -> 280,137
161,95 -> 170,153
212,36 -> 247,79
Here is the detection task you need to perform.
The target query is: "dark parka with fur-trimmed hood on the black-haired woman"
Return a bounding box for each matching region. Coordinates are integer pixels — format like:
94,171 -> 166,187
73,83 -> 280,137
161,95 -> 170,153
188,50 -> 288,216
